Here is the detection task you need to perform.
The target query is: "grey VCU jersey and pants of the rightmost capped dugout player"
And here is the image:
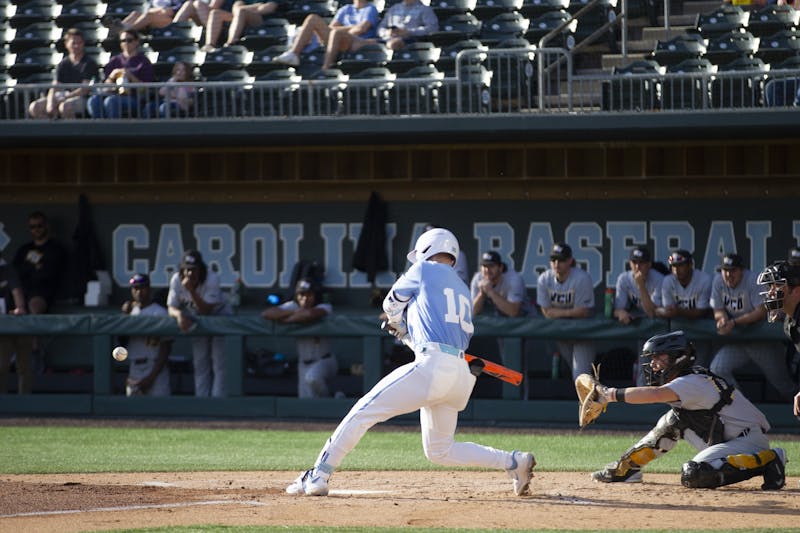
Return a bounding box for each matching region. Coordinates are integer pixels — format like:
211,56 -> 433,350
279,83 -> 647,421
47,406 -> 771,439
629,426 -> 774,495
710,270 -> 796,400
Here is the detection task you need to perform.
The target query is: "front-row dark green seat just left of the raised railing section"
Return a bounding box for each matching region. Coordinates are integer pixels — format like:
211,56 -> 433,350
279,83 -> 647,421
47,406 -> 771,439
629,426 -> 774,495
389,65 -> 444,115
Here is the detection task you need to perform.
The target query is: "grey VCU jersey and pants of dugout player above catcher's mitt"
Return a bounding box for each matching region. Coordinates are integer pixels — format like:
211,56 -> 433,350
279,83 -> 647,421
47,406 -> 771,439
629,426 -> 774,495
536,266 -> 597,381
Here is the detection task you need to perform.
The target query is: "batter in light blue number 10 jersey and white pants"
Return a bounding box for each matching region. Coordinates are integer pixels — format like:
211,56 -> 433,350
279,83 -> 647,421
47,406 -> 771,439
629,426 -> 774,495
286,228 -> 536,496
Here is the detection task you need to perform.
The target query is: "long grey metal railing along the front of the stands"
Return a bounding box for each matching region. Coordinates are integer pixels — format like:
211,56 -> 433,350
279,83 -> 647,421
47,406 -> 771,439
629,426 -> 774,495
0,47 -> 800,120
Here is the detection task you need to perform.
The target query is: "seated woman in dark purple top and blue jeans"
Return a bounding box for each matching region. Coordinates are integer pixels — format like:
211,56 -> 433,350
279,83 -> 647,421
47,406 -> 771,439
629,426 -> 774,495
87,30 -> 155,118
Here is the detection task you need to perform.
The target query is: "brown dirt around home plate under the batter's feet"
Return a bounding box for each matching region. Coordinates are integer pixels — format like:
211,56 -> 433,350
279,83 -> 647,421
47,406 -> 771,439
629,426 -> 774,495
0,471 -> 800,533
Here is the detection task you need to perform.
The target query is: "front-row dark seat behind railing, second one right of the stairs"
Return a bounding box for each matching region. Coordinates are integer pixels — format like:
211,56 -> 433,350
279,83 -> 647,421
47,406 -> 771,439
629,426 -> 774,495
661,58 -> 717,110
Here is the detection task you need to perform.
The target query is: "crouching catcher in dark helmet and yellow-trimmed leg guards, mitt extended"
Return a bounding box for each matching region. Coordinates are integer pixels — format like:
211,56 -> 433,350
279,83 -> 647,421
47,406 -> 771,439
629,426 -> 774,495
575,331 -> 786,490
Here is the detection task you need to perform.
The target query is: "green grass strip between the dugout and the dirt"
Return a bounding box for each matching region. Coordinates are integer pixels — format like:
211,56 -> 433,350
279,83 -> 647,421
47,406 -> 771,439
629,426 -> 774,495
0,426 -> 800,476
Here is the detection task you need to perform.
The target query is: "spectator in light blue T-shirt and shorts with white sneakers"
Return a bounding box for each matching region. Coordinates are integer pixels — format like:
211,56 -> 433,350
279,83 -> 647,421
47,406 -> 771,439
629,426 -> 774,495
274,0 -> 380,69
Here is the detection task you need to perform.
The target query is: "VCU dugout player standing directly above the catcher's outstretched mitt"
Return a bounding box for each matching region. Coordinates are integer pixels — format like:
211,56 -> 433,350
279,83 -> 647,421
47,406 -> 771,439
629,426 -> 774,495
536,242 -> 597,380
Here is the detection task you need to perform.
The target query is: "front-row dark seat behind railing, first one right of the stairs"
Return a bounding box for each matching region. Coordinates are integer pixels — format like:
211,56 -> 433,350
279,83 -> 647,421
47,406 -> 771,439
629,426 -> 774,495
602,60 -> 666,111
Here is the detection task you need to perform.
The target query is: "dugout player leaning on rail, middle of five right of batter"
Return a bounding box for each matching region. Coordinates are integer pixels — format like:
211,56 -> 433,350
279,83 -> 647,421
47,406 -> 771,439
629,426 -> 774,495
614,246 -> 664,324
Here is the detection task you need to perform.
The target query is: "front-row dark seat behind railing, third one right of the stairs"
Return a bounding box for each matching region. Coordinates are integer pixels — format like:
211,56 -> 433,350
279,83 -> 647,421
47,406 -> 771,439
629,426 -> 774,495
711,57 -> 769,108
